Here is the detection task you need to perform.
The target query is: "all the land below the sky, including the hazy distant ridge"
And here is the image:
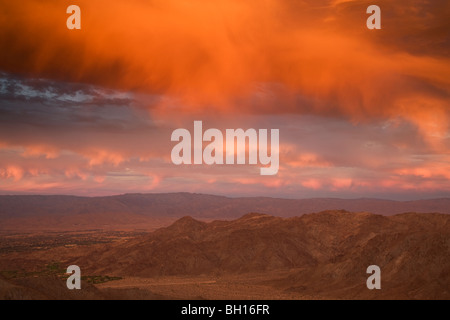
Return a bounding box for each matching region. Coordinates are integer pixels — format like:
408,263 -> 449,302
0,194 -> 450,300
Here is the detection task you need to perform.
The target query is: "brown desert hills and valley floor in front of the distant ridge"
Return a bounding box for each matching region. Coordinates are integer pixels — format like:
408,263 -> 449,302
0,202 -> 450,300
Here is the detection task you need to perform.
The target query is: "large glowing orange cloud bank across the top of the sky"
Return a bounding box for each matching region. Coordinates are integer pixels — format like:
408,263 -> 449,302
0,0 -> 450,125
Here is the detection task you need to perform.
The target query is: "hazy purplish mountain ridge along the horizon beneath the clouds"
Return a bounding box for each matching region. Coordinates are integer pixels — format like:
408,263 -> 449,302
0,193 -> 450,219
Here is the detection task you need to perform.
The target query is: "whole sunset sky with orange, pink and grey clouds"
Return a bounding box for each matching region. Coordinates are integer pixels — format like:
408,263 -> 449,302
0,0 -> 450,200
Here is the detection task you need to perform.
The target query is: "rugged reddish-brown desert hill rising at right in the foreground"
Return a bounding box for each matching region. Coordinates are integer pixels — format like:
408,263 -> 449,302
75,210 -> 450,299
